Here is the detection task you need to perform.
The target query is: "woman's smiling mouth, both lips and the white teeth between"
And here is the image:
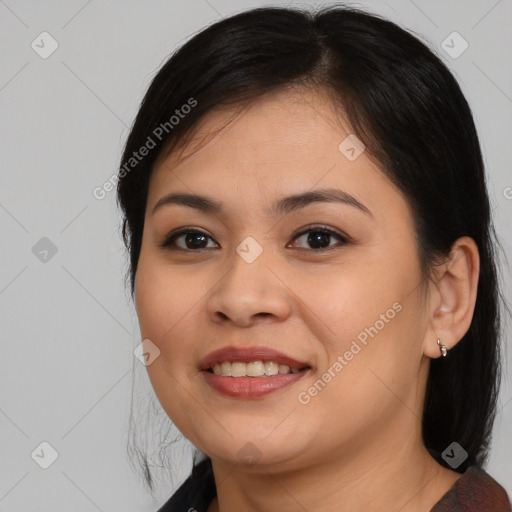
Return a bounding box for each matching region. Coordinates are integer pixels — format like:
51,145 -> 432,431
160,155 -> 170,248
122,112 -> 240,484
200,347 -> 312,399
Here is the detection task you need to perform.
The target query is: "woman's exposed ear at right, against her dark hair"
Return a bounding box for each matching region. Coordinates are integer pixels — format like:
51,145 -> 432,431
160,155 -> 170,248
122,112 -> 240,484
423,236 -> 480,359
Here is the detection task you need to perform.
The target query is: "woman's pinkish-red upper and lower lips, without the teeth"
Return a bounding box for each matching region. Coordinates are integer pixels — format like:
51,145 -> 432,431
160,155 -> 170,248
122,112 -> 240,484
199,347 -> 311,400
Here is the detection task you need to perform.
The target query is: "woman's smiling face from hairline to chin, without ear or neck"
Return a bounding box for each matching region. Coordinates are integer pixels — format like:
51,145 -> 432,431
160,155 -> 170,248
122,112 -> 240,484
135,91 -> 428,470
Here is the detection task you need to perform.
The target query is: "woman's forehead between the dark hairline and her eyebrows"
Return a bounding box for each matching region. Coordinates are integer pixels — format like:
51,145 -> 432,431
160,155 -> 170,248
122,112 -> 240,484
148,89 -> 404,216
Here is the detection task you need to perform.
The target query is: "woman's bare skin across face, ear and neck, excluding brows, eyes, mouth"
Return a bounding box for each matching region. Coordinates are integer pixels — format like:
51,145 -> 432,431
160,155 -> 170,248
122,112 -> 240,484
135,89 -> 479,512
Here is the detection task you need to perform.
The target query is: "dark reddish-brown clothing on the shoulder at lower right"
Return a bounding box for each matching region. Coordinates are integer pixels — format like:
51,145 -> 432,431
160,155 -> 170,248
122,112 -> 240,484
431,466 -> 512,512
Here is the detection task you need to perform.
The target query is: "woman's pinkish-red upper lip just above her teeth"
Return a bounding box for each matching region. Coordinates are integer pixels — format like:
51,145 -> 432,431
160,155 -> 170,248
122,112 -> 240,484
199,346 -> 310,370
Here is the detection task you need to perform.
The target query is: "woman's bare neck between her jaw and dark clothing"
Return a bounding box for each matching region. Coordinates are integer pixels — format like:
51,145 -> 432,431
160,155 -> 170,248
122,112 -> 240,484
208,425 -> 460,512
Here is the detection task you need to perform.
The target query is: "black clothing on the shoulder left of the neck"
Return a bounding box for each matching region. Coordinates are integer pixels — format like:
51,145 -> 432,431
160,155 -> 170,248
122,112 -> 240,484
157,458 -> 217,512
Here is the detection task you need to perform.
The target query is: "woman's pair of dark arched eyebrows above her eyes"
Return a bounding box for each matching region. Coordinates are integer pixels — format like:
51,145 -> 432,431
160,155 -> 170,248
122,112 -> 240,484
153,188 -> 373,217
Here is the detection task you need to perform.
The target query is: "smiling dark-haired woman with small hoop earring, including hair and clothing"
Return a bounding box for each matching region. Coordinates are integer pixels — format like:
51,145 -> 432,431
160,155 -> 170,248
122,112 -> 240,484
118,7 -> 510,512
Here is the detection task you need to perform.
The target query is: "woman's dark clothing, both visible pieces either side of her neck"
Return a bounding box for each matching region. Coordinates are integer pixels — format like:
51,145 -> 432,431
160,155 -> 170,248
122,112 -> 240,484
157,459 -> 512,512
